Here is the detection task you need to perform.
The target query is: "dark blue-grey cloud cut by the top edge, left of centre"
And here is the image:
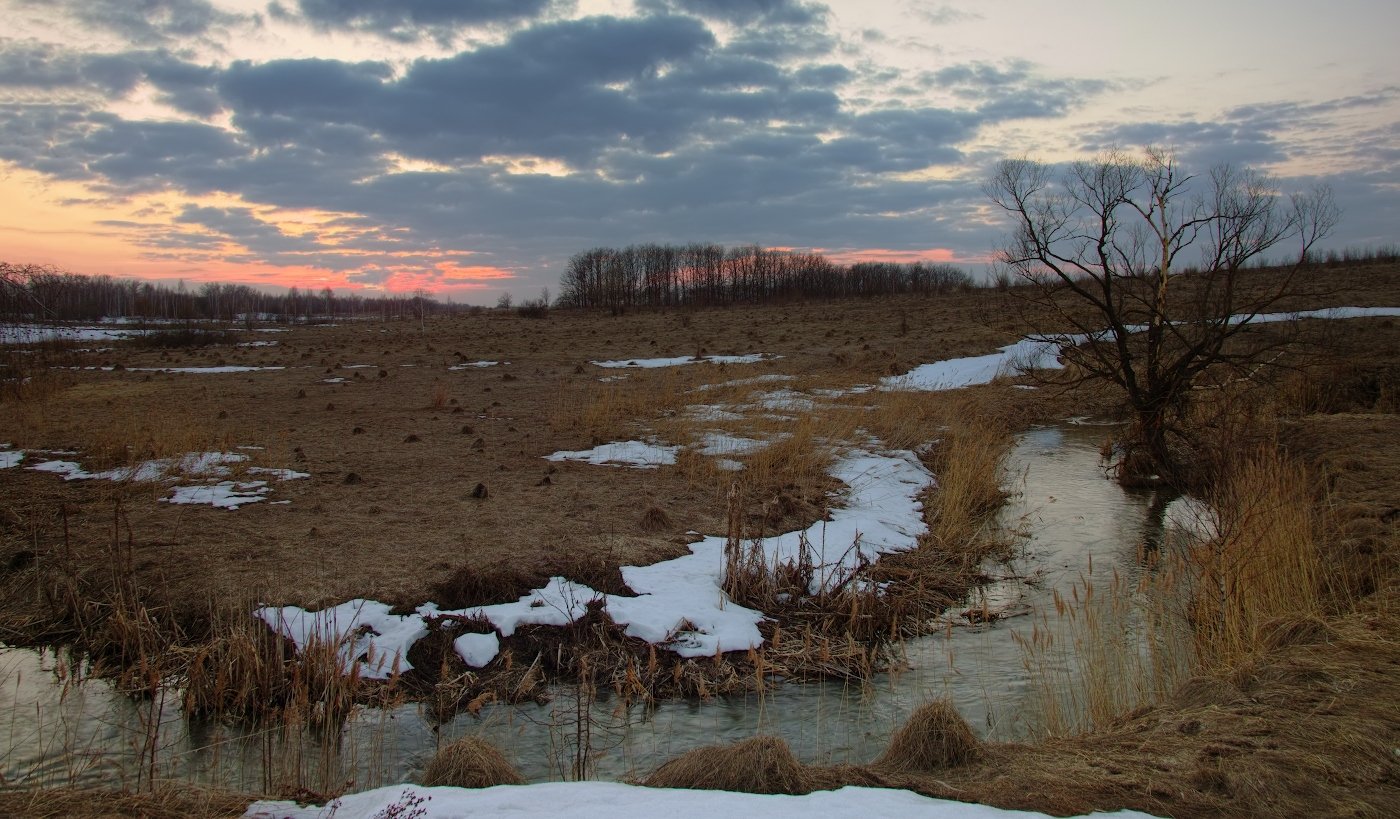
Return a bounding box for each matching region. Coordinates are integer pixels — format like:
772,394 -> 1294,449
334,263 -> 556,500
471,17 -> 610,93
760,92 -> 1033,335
267,0 -> 561,39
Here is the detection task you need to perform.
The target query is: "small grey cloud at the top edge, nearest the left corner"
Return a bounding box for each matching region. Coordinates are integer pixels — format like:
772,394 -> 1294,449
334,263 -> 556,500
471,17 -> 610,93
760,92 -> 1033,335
21,0 -> 249,45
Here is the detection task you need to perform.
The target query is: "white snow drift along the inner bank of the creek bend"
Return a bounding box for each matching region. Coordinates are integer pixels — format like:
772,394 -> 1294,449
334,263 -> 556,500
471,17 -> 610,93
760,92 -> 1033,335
255,451 -> 934,679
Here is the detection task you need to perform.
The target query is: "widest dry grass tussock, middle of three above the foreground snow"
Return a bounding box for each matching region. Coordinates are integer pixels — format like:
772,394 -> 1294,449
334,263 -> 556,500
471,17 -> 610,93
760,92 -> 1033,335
643,736 -> 818,794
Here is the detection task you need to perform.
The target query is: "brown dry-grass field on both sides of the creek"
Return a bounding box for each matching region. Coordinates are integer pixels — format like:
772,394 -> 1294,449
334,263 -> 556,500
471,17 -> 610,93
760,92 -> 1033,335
0,265 -> 1400,815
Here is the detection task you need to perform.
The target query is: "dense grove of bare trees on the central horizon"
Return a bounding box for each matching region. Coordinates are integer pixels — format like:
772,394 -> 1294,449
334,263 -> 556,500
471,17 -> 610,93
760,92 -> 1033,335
557,244 -> 973,312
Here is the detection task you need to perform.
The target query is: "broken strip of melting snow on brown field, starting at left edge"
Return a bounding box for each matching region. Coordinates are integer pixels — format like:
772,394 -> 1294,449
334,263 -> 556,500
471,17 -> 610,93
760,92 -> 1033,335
17,451 -> 311,510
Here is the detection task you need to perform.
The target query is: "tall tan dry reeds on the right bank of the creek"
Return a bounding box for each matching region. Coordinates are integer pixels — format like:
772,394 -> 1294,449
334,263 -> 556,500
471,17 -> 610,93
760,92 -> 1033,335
1015,436 -> 1340,736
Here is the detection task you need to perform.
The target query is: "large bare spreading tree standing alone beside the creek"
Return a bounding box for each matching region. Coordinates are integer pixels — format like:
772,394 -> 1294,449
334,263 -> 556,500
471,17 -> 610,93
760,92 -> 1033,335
984,148 -> 1338,480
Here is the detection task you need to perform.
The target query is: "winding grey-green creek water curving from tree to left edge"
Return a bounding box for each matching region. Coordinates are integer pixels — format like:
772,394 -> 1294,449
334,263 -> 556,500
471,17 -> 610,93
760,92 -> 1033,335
0,426 -> 1166,791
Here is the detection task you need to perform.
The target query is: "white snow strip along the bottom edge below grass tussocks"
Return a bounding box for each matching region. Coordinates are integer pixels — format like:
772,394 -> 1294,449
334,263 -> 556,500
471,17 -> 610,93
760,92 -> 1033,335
244,783 -> 1148,819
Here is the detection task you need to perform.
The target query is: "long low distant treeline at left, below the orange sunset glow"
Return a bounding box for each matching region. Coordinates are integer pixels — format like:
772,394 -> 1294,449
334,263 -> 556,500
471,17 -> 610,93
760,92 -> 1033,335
0,262 -> 448,322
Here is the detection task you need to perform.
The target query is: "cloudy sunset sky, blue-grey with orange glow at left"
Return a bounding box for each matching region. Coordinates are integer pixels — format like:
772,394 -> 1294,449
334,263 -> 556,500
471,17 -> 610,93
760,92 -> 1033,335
0,0 -> 1400,304
